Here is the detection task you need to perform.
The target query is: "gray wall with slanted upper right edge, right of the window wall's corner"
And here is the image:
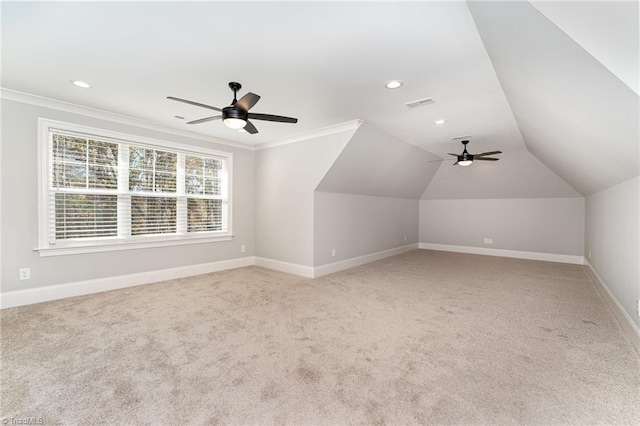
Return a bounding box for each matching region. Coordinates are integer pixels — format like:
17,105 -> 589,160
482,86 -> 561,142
256,130 -> 354,266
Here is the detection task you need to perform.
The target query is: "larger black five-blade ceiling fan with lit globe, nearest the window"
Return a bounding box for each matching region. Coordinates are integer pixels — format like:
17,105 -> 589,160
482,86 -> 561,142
167,81 -> 298,135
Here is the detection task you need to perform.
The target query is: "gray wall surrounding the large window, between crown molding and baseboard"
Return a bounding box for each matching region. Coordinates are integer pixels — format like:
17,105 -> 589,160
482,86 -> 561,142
0,100 -> 255,292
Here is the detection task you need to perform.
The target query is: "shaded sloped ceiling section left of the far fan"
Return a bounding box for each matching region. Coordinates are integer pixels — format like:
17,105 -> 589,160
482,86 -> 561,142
316,123 -> 440,199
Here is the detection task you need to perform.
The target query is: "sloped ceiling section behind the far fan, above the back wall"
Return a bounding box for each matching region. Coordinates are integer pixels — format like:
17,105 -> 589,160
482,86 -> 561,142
422,144 -> 581,199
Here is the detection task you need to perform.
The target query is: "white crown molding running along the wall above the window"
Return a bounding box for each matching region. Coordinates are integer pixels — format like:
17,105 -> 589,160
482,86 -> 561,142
0,87 -> 255,151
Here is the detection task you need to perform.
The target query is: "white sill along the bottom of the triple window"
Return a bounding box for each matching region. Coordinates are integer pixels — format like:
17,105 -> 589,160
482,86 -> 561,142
34,234 -> 233,257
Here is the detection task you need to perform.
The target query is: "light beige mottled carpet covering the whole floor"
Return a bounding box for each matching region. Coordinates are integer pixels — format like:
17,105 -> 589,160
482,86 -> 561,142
1,250 -> 640,425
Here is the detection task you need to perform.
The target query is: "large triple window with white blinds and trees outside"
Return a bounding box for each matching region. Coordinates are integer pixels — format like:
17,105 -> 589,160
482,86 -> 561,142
39,119 -> 232,255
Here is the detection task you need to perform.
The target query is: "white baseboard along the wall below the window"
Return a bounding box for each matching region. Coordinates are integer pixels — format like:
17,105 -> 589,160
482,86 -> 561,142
0,256 -> 255,309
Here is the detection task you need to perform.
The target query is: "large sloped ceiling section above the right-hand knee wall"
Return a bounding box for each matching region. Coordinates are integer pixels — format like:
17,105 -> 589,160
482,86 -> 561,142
469,2 -> 640,195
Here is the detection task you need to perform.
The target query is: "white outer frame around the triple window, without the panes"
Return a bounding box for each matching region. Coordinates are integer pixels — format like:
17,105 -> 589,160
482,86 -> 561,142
35,118 -> 233,257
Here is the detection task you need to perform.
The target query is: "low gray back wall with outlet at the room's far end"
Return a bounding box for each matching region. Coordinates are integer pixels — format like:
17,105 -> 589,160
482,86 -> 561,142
420,198 -> 584,256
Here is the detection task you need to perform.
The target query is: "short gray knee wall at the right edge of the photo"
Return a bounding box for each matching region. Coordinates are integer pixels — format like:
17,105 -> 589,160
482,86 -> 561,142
585,177 -> 640,327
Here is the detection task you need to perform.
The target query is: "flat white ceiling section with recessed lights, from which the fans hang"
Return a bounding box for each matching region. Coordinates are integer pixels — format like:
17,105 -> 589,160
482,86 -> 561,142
2,2 -> 523,155
